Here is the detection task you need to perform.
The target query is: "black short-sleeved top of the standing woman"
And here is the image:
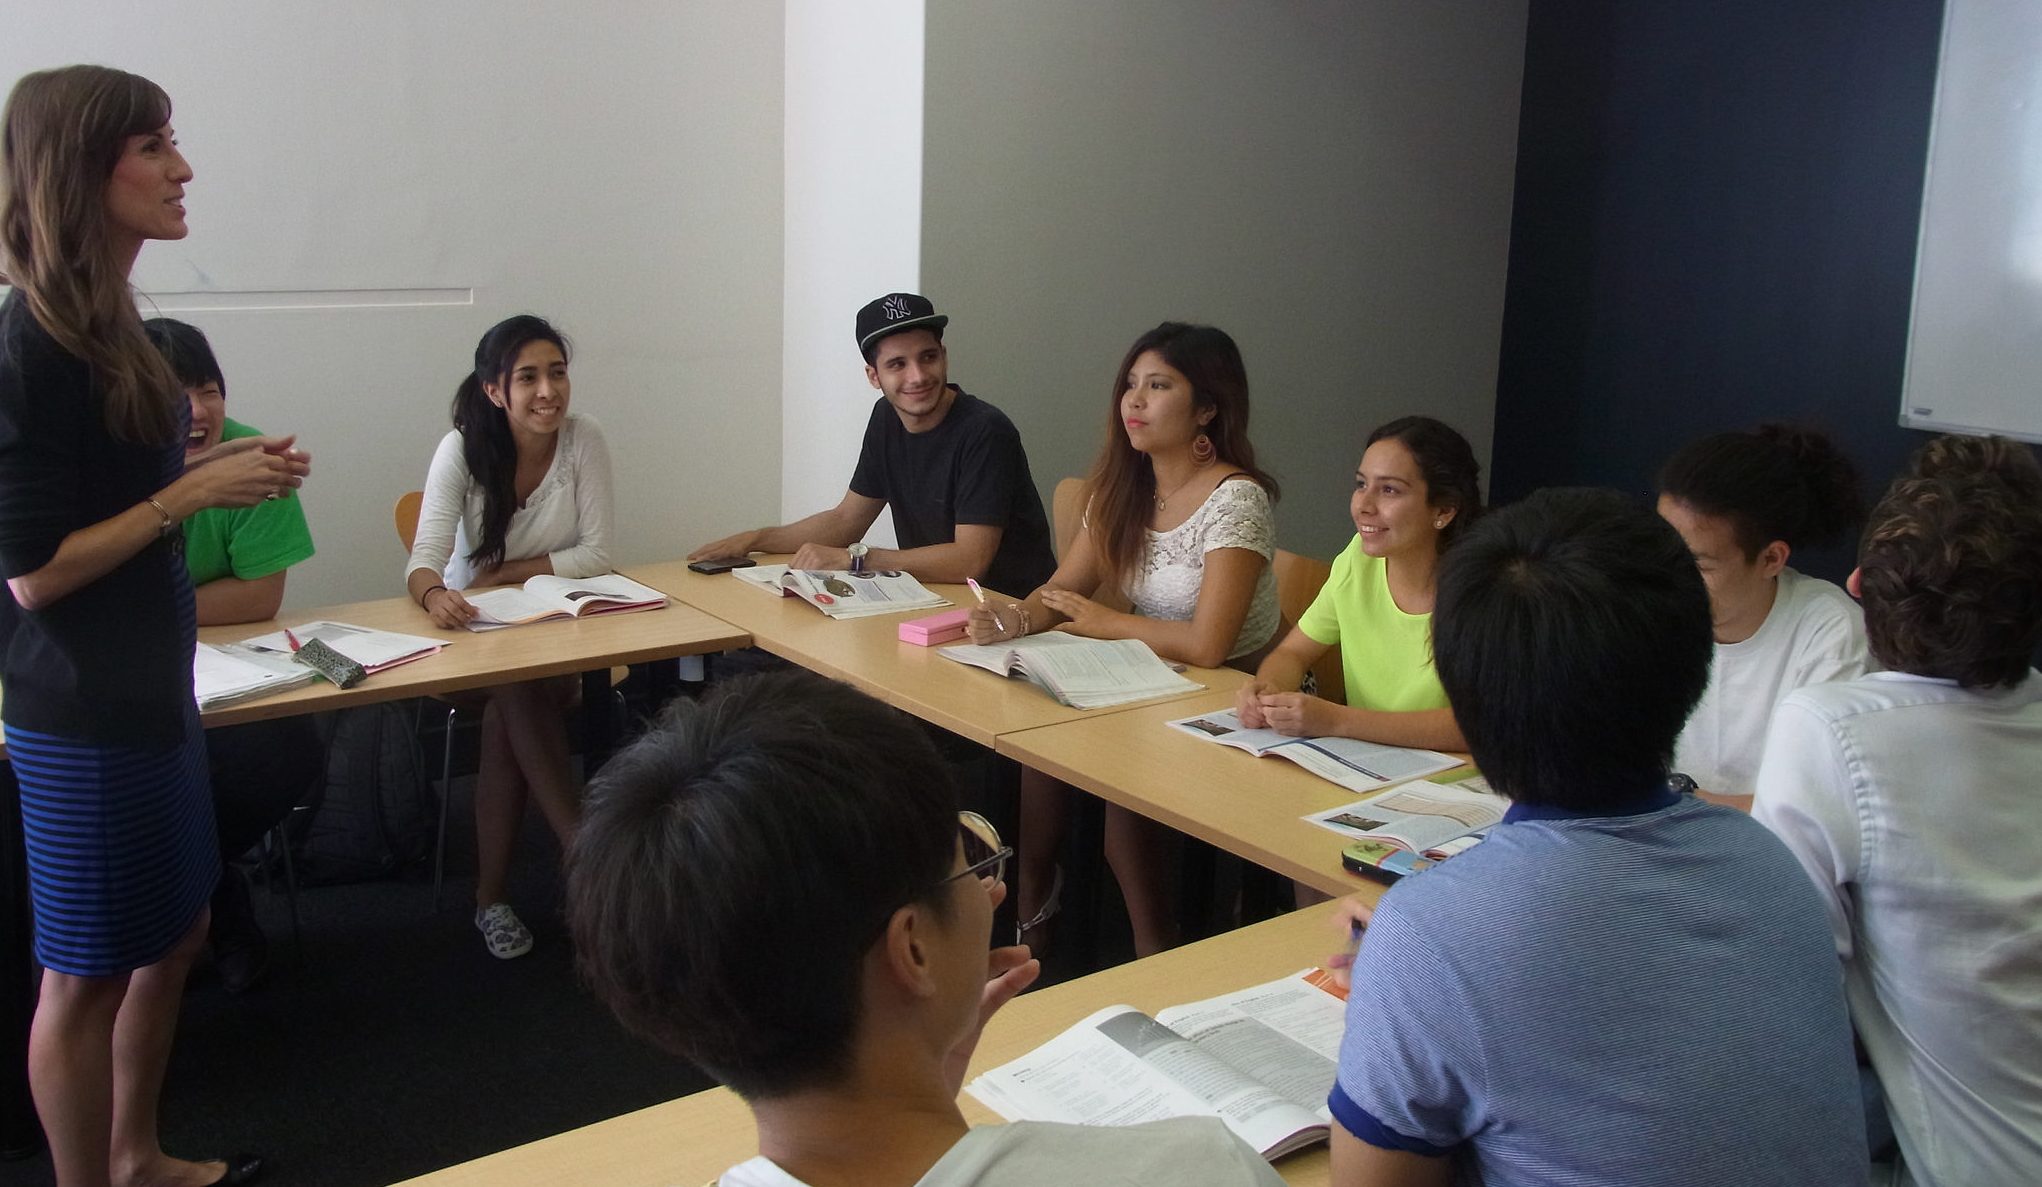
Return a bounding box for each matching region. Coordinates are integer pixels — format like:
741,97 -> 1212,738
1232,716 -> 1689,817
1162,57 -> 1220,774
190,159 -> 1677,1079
0,292 -> 196,748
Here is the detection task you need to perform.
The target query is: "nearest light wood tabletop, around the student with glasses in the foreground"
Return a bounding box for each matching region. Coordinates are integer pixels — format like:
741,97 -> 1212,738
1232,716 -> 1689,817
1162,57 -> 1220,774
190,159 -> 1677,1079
400,898 -> 1338,1187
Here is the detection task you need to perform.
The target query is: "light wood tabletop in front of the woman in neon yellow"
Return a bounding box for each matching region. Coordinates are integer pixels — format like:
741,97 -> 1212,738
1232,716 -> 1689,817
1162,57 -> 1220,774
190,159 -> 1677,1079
996,693 -> 1462,895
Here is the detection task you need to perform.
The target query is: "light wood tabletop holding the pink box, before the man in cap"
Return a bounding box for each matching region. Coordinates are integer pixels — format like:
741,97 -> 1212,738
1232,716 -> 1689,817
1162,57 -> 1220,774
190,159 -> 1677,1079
625,560 -> 1248,746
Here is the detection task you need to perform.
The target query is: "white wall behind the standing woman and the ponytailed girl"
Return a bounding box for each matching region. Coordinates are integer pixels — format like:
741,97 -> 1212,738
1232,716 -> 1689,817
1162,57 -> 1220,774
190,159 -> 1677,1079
0,0 -> 782,607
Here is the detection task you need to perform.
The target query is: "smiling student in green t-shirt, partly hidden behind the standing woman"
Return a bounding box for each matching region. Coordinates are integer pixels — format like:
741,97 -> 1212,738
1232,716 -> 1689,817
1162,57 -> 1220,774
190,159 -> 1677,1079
143,317 -> 327,993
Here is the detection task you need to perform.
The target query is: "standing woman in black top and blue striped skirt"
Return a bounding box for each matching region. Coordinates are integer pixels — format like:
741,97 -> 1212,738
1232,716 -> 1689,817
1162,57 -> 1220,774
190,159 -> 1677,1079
0,65 -> 308,1187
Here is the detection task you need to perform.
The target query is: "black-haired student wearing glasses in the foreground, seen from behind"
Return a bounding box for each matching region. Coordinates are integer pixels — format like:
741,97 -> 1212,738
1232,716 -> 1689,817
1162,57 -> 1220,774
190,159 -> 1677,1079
568,672 -> 1280,1187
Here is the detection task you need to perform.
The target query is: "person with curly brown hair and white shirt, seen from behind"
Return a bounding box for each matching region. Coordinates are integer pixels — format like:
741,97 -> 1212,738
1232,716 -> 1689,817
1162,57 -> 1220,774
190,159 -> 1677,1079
1752,437 -> 2042,1187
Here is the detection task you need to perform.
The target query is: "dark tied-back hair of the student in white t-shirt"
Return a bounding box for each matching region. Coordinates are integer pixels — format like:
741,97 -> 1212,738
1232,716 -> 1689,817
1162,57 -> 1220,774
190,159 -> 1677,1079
1658,425 -> 1864,560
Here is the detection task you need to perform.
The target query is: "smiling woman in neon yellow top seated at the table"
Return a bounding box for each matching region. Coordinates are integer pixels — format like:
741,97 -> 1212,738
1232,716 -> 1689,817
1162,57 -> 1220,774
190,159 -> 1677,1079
1235,417 -> 1482,750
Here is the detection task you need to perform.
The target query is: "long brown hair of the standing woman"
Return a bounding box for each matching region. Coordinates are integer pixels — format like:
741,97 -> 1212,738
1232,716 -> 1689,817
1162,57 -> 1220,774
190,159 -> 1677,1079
0,65 -> 184,445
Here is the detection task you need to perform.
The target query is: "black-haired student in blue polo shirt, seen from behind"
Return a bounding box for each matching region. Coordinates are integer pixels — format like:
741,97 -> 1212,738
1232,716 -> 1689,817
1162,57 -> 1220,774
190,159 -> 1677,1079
1329,490 -> 1866,1187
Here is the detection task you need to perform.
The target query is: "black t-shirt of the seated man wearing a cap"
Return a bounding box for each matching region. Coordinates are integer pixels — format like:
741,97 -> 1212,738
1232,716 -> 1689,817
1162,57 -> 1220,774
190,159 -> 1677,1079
852,384 -> 1056,597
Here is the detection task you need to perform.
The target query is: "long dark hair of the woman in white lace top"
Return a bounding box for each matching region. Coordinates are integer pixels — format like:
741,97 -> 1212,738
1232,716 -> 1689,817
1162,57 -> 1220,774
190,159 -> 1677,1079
1086,321 -> 1278,586
